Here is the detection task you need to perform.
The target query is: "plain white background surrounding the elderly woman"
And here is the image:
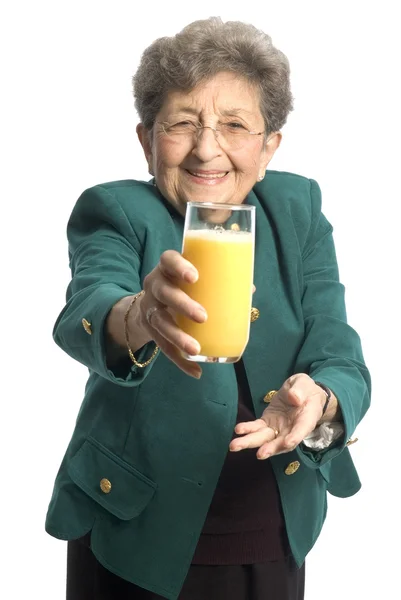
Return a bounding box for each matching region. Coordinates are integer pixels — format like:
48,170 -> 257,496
0,0 -> 401,600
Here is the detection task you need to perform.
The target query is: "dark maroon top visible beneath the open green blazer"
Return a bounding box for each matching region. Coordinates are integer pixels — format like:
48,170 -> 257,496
192,361 -> 290,565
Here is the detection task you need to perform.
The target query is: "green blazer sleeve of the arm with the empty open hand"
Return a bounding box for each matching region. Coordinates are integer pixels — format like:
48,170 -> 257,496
294,180 -> 371,468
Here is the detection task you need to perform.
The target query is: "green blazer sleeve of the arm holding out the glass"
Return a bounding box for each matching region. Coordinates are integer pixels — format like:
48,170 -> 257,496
53,186 -> 158,386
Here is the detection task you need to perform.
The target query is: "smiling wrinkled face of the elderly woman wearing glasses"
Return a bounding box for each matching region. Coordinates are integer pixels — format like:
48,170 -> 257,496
137,72 -> 281,214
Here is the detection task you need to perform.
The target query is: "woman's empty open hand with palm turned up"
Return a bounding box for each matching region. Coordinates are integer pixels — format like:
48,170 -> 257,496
230,373 -> 326,459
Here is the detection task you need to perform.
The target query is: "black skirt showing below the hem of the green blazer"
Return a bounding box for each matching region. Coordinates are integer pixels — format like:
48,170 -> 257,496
67,539 -> 305,600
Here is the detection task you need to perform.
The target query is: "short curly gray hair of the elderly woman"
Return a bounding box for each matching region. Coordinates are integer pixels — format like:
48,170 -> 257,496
132,17 -> 293,134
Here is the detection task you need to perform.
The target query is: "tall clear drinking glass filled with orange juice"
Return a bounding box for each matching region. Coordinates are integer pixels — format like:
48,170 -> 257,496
177,202 -> 255,363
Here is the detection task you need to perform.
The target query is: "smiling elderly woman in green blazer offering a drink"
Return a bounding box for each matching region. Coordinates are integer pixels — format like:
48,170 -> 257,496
46,18 -> 370,600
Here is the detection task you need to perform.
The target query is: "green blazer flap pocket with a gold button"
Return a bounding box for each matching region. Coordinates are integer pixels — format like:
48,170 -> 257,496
68,437 -> 157,521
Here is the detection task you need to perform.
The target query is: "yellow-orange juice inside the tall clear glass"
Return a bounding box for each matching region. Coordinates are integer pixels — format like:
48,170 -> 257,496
177,230 -> 254,358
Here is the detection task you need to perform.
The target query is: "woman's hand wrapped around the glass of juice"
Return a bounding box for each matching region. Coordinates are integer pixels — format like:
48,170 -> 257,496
136,250 -> 207,379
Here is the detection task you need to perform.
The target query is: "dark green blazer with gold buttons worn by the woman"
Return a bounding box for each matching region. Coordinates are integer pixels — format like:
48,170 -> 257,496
46,171 -> 370,600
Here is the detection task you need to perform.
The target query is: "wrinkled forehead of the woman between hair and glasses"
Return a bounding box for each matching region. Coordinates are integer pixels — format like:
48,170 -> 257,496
160,73 -> 261,118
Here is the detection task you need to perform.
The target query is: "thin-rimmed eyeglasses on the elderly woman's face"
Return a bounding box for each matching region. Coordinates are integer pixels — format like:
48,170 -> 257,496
157,121 -> 265,149
